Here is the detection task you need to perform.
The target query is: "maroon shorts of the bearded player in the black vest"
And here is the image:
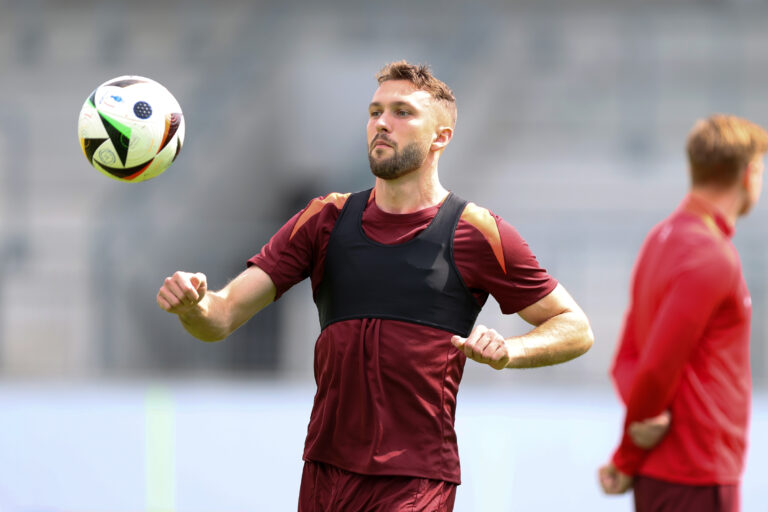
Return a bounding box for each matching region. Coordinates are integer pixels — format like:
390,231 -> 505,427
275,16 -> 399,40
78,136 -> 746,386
299,462 -> 456,512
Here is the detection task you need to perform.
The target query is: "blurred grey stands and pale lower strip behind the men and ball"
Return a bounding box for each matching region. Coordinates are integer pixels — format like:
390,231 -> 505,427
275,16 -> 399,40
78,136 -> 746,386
0,0 -> 768,512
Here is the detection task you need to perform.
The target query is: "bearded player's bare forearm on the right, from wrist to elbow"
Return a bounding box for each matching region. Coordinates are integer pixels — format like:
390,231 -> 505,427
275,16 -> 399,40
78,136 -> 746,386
506,311 -> 594,368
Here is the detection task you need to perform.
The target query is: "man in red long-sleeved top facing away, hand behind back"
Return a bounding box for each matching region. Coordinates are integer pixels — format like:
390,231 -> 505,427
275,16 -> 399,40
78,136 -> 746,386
599,115 -> 768,512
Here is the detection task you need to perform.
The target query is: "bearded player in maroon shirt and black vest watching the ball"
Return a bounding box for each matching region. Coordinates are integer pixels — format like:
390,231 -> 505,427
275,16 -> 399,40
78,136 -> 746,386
157,62 -> 593,512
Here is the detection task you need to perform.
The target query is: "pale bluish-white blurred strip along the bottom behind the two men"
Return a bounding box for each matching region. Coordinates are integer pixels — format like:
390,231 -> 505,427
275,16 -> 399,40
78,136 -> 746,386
0,380 -> 768,512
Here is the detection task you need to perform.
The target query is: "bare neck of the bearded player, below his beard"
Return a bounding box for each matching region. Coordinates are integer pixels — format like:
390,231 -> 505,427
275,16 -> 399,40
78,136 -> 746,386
375,161 -> 448,213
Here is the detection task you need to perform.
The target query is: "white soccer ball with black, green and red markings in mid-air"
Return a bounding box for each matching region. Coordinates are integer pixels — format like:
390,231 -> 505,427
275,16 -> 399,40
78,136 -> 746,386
77,75 -> 184,182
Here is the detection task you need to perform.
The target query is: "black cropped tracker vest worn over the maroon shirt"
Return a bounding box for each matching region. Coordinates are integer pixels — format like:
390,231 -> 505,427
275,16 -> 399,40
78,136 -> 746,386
315,190 -> 481,336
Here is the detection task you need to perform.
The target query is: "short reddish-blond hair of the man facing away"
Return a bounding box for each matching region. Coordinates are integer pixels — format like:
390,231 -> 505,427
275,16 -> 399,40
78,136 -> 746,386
686,114 -> 768,186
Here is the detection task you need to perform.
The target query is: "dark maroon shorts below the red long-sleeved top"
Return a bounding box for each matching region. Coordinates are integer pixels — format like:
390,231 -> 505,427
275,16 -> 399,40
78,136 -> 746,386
633,476 -> 740,512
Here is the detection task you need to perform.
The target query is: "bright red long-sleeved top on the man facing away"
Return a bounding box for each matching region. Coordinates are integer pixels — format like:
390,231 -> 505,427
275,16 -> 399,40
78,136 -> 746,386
612,194 -> 752,485
